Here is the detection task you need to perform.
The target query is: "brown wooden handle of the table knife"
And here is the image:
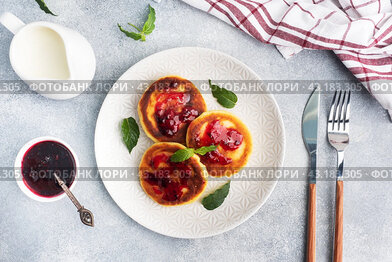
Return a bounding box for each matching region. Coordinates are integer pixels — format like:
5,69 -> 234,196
306,184 -> 316,262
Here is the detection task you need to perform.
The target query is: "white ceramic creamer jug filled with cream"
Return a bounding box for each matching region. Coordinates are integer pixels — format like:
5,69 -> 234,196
0,12 -> 96,99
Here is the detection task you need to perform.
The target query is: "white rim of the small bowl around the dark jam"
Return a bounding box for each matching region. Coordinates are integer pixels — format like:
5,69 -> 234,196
14,136 -> 79,202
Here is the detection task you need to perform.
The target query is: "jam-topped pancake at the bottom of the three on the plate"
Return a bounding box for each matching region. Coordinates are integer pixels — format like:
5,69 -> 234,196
139,142 -> 208,206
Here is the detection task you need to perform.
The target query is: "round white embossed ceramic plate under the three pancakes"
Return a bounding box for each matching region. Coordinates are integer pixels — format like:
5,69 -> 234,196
95,47 -> 285,238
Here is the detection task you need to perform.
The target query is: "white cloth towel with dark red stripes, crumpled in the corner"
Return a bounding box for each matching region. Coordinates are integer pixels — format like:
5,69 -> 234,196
183,0 -> 392,116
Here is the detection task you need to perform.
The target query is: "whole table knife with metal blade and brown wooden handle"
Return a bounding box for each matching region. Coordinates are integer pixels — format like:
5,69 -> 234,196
302,85 -> 320,262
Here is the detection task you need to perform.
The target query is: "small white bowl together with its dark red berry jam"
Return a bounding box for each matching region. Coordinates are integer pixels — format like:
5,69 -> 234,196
15,137 -> 79,202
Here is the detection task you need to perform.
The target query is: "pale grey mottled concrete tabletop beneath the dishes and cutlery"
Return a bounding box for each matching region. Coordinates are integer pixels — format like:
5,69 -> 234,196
0,0 -> 392,262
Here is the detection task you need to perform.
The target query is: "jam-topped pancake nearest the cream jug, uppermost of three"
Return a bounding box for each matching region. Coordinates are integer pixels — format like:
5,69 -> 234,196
138,76 -> 207,144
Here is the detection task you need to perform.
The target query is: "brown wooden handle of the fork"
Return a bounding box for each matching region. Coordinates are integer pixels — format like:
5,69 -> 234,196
333,181 -> 343,262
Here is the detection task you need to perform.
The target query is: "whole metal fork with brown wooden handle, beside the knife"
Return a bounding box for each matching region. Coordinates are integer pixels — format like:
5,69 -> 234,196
328,90 -> 351,262
